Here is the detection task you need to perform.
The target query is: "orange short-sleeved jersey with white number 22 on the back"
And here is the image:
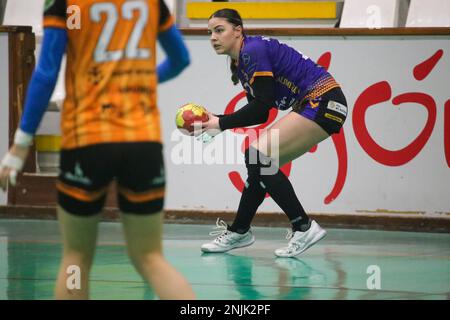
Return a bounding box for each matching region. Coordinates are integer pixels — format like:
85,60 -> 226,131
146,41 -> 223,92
44,0 -> 173,149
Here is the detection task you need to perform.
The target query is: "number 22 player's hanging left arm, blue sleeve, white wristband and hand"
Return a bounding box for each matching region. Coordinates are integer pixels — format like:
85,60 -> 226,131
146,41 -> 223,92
0,28 -> 67,190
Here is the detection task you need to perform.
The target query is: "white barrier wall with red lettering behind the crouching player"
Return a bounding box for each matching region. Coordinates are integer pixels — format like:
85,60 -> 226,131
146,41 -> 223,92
159,36 -> 450,214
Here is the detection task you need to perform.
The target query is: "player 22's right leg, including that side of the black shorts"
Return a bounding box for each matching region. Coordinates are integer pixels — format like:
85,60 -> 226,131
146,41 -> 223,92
118,143 -> 195,299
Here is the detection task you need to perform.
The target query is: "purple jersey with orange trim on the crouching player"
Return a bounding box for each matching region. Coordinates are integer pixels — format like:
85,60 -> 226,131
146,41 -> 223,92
237,36 -> 339,110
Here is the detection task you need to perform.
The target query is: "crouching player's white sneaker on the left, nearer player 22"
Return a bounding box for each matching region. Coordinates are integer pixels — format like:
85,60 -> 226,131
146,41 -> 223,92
201,219 -> 255,252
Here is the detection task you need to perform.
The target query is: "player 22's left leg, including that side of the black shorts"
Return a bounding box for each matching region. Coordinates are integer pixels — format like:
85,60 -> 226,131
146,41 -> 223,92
55,145 -> 114,299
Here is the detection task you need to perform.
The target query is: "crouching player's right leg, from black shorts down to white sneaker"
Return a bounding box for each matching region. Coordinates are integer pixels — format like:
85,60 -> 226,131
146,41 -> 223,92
251,89 -> 345,256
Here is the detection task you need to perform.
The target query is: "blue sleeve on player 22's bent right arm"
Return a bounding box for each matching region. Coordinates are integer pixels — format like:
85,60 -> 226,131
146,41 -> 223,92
157,25 -> 190,83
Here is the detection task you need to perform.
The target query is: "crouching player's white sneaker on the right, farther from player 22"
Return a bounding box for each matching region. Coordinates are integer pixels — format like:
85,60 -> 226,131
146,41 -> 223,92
275,220 -> 327,257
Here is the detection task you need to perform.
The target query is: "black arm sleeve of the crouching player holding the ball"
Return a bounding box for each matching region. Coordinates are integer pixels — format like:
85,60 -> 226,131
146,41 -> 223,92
219,76 -> 275,130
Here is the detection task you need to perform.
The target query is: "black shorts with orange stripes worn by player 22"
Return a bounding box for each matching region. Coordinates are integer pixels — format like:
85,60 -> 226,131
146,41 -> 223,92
57,142 -> 165,216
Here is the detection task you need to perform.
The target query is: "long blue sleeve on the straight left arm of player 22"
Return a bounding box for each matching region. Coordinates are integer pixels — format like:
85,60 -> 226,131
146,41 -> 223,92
20,28 -> 67,135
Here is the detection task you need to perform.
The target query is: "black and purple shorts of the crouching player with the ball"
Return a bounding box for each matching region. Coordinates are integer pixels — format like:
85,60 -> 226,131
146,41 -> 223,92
293,88 -> 347,136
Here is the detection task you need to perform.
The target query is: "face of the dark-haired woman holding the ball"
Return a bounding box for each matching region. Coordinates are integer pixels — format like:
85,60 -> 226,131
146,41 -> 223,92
208,18 -> 242,58
